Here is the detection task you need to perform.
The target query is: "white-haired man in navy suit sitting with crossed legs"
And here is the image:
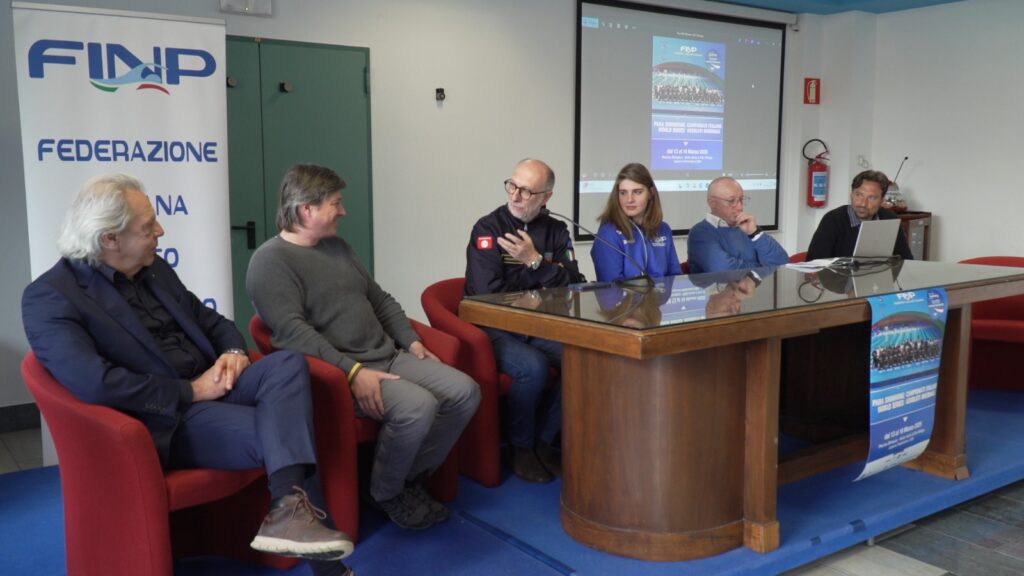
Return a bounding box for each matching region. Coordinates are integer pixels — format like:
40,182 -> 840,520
22,174 -> 353,575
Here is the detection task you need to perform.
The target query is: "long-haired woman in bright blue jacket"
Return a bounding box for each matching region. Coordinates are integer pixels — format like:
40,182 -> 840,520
590,163 -> 682,282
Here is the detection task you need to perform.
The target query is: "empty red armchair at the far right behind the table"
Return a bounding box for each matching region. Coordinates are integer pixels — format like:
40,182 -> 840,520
961,256 -> 1024,389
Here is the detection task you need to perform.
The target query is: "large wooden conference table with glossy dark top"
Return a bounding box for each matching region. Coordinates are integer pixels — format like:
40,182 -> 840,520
460,261 -> 1024,561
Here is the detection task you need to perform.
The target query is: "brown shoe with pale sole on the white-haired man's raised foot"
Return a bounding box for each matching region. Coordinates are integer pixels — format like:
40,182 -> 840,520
250,486 -> 354,560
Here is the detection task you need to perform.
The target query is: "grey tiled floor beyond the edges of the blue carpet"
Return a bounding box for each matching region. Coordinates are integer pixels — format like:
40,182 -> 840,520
6,428 -> 1024,576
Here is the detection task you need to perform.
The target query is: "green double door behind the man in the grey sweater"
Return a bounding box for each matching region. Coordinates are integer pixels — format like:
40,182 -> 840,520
227,37 -> 374,344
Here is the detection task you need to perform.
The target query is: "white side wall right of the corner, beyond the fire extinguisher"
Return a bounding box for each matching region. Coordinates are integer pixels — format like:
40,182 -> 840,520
872,0 -> 1024,261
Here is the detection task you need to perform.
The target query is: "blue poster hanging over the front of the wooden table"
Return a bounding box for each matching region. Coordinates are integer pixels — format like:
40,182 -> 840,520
856,288 -> 948,480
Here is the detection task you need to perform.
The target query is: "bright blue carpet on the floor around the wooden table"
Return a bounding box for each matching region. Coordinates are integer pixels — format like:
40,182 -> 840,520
6,385 -> 1024,576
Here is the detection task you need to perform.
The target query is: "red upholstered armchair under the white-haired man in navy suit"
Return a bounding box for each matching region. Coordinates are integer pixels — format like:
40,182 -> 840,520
22,353 -> 298,576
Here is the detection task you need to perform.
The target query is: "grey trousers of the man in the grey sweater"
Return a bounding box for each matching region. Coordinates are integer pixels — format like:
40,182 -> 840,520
355,351 -> 480,501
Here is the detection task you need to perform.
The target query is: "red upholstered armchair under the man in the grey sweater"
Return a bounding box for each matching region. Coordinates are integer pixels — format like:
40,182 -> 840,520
249,315 -> 459,539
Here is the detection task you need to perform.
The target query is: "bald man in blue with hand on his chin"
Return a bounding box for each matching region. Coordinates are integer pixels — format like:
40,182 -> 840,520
686,176 -> 790,274
